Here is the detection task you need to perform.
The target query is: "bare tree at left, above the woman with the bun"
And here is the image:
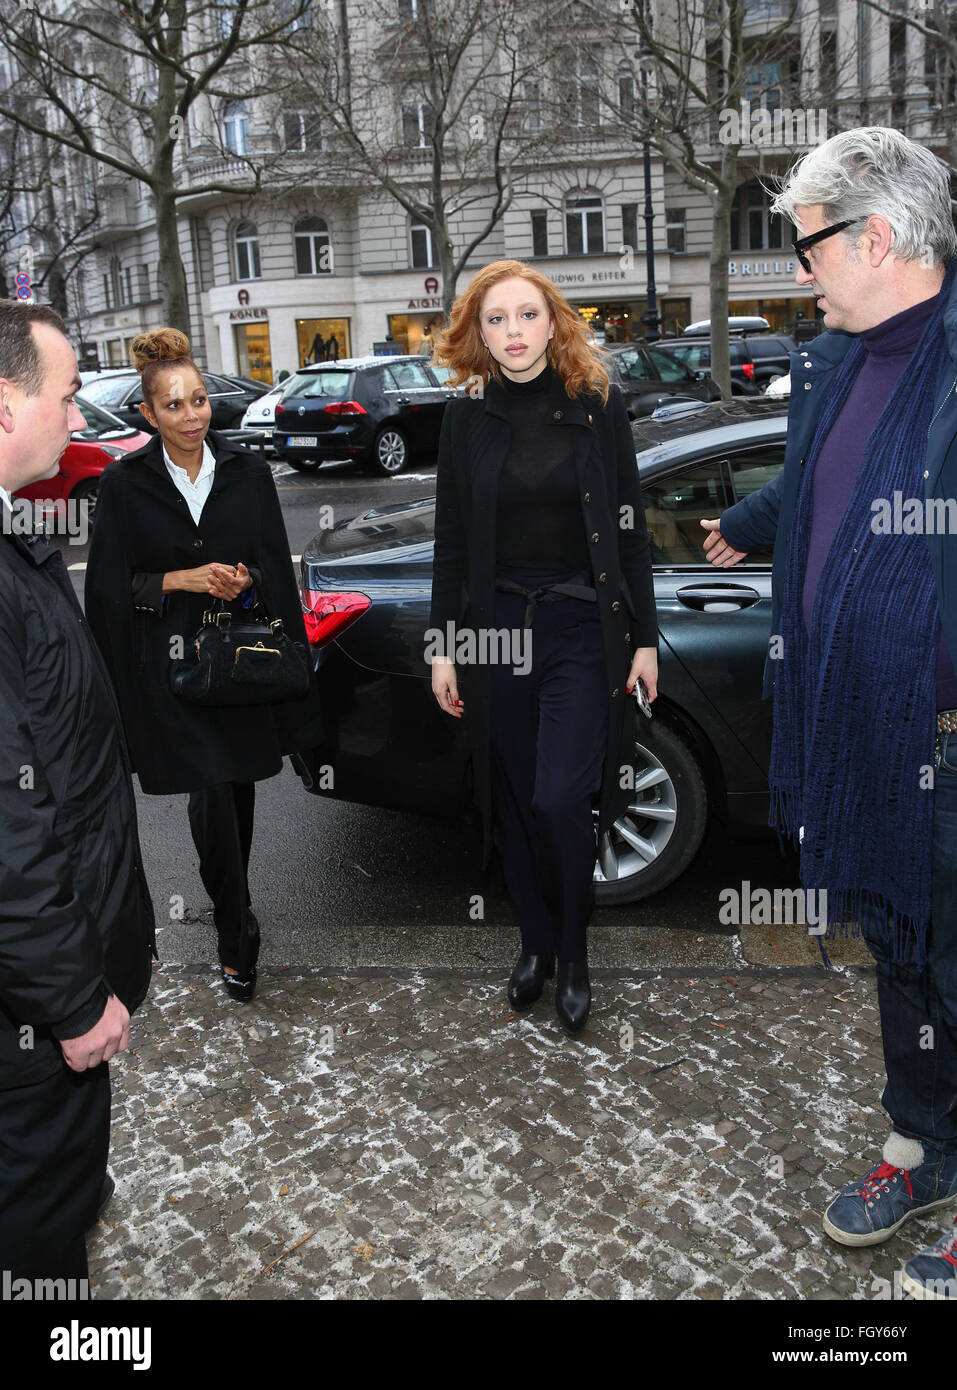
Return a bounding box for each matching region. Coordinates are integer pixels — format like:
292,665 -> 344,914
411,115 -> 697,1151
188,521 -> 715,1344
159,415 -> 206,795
0,0 -> 320,325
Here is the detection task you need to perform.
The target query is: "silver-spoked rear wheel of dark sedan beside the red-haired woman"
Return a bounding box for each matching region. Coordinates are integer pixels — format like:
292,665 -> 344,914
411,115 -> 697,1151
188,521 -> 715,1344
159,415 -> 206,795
594,710 -> 708,906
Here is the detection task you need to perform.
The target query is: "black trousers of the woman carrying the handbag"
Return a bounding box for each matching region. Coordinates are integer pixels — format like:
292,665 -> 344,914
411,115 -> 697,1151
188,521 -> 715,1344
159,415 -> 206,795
189,783 -> 259,979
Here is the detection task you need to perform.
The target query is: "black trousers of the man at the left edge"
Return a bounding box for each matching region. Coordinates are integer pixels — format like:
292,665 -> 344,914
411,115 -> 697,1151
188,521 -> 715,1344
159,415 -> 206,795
0,1062 -> 110,1279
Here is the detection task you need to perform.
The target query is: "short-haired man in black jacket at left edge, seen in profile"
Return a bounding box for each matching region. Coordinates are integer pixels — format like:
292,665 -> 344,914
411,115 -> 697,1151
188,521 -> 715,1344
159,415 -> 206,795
0,300 -> 154,1279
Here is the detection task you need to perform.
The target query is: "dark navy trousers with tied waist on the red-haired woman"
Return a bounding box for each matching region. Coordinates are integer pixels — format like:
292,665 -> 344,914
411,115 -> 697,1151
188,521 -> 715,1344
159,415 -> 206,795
491,575 -> 608,960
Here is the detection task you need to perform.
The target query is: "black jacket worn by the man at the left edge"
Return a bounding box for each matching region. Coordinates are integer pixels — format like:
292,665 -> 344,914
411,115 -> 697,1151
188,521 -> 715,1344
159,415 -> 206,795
0,517 -> 154,1090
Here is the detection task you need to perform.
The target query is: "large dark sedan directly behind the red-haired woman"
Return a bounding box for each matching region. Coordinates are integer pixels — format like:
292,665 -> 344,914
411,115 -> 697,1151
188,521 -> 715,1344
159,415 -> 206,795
293,400 -> 787,904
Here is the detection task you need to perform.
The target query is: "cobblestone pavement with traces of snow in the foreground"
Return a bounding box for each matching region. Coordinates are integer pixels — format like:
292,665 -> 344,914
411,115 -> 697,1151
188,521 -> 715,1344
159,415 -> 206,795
89,966 -> 934,1300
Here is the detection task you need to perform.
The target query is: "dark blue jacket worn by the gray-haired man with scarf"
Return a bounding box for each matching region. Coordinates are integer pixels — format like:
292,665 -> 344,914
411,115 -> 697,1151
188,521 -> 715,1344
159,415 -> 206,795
721,269 -> 957,699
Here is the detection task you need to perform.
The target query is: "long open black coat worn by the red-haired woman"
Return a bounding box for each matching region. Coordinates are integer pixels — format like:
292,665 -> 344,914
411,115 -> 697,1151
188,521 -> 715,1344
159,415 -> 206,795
430,375 -> 658,863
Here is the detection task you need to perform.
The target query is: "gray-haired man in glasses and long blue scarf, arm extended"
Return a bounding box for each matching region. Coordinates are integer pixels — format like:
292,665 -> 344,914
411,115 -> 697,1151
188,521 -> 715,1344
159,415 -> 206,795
702,126 -> 957,1298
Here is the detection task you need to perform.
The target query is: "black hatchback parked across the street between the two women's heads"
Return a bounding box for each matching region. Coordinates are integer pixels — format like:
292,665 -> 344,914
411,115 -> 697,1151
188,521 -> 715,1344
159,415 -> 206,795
273,356 -> 456,477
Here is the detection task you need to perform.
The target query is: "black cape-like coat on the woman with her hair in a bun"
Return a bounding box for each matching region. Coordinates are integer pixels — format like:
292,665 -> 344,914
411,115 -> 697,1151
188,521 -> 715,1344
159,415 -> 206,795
85,431 -> 321,792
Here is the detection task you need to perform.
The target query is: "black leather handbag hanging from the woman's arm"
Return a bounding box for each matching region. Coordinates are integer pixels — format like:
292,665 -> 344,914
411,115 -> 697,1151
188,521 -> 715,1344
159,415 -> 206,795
172,599 -> 309,705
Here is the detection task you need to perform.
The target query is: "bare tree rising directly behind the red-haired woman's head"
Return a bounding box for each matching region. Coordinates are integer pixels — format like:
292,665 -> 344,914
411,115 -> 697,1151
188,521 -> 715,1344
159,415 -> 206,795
280,0 -> 554,314
